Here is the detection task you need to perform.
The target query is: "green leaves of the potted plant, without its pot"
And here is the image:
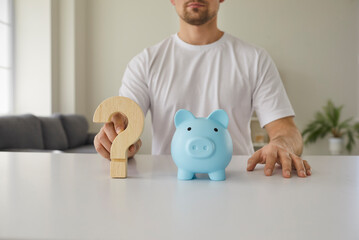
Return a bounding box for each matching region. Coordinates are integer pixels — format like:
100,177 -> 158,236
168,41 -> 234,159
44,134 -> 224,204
302,100 -> 359,152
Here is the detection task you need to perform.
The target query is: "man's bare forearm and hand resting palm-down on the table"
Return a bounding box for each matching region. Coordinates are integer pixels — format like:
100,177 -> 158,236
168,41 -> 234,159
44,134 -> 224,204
247,117 -> 311,177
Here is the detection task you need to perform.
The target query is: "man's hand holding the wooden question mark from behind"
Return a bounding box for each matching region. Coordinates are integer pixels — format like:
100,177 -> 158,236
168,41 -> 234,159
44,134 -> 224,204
94,113 -> 142,160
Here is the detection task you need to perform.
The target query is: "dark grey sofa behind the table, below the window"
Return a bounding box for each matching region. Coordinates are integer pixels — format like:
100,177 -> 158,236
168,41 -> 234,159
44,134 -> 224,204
0,114 -> 96,153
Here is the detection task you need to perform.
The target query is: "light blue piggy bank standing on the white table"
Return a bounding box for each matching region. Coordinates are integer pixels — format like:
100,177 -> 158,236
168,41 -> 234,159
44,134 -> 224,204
171,109 -> 233,181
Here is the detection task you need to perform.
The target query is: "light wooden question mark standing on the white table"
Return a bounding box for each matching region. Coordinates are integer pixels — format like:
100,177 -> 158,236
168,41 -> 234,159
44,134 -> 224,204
93,96 -> 144,178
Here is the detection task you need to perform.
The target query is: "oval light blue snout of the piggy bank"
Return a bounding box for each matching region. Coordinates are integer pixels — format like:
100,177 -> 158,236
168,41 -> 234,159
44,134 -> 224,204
186,137 -> 215,158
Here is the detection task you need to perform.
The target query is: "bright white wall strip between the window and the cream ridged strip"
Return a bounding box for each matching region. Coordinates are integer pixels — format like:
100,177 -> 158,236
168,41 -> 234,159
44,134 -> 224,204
14,0 -> 51,115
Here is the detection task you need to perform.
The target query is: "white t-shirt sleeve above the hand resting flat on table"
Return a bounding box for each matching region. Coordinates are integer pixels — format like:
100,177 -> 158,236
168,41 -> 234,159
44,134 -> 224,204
252,50 -> 295,128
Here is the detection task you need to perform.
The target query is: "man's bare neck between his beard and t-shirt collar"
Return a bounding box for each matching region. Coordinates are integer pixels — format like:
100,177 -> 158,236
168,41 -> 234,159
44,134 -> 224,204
178,17 -> 224,45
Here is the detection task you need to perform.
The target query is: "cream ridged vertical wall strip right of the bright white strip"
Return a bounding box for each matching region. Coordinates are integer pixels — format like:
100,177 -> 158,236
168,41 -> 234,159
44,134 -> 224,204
52,0 -> 87,115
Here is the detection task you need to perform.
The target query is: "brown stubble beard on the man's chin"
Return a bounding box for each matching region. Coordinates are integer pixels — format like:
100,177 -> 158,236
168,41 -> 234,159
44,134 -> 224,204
182,1 -> 216,26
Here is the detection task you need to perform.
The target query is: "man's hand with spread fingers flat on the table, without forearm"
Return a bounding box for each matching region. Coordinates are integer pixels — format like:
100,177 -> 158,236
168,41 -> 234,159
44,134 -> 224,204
247,143 -> 312,178
